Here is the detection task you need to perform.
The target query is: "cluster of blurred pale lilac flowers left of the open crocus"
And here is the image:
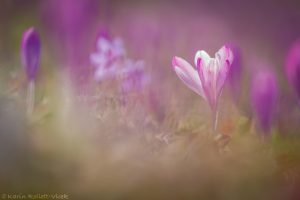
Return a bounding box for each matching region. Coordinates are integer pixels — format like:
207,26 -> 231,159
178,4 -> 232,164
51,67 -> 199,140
90,33 -> 149,93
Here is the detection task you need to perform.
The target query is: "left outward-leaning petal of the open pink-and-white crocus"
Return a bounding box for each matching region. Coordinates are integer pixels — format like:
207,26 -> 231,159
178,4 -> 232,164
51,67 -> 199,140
172,57 -> 206,99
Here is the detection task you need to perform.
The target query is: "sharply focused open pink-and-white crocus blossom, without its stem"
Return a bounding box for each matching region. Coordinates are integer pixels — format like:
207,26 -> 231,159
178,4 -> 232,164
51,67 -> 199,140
172,46 -> 233,111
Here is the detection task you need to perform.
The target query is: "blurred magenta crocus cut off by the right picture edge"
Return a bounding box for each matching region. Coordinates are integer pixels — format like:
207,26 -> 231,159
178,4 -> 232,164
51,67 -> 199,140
285,40 -> 300,98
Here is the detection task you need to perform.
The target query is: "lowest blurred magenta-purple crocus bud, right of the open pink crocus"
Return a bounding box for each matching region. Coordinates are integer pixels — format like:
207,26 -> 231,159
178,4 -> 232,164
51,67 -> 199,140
251,70 -> 278,134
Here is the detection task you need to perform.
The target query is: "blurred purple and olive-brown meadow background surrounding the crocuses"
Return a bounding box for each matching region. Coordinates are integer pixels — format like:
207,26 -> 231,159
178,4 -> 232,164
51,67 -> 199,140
0,0 -> 300,200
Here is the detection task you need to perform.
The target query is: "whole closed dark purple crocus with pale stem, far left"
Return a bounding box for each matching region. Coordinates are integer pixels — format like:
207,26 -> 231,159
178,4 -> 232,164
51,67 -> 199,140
21,28 -> 41,114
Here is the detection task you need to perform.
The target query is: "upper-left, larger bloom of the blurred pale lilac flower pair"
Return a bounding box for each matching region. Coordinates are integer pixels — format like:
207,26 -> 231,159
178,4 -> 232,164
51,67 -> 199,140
90,34 -> 125,81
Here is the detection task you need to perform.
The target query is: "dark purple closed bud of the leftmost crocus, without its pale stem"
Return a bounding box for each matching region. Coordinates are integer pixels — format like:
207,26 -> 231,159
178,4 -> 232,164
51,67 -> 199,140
21,28 -> 41,81
